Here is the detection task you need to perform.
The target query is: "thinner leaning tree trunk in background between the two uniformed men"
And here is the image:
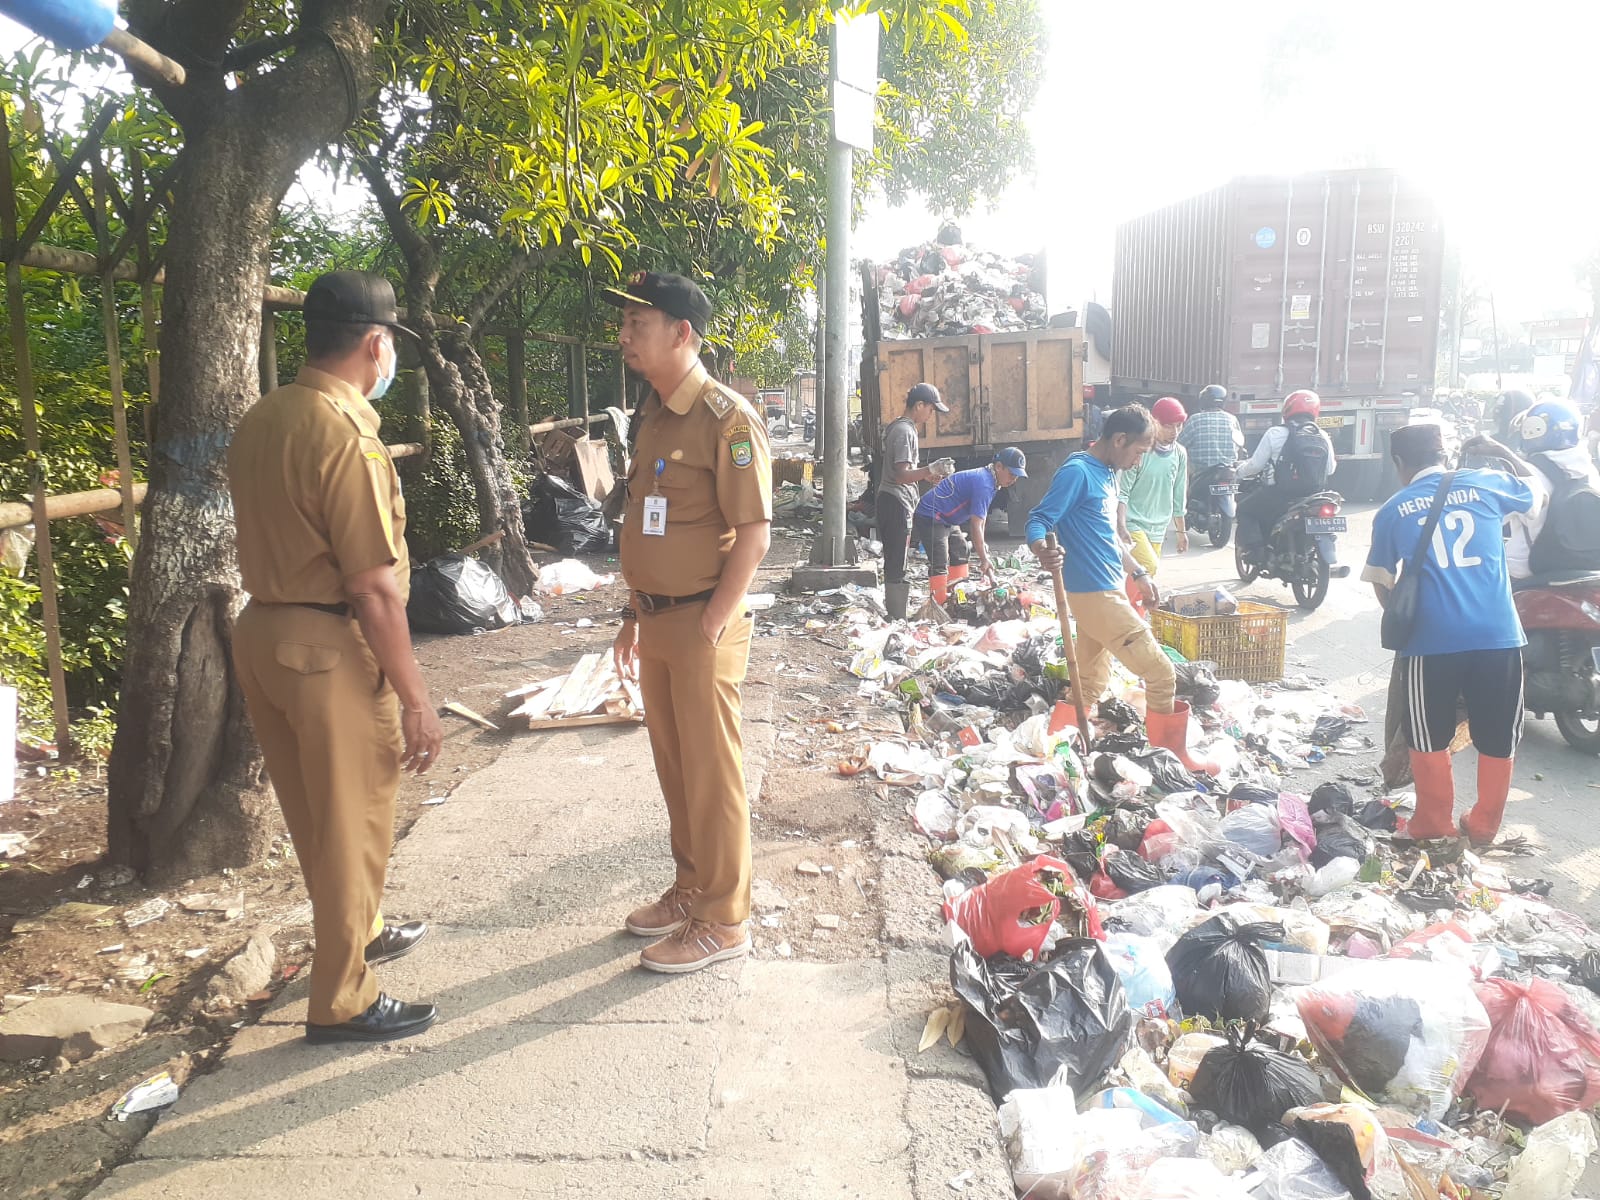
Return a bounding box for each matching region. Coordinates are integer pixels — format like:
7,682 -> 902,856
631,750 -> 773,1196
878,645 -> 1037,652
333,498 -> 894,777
422,330 -> 539,597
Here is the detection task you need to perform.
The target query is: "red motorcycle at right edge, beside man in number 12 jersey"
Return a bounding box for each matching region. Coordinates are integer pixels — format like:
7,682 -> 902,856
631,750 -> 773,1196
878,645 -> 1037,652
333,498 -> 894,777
1512,571 -> 1600,754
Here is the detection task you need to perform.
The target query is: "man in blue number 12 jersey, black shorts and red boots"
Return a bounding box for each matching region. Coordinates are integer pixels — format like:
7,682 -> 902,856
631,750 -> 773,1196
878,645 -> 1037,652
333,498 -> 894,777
1362,426 -> 1542,845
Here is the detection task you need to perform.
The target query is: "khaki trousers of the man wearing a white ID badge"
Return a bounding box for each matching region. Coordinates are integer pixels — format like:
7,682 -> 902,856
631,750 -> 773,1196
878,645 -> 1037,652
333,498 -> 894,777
638,605 -> 755,925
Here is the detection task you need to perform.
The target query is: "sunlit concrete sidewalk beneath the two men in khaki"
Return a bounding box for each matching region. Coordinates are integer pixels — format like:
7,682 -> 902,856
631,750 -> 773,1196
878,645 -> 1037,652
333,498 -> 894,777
93,688 -> 1013,1200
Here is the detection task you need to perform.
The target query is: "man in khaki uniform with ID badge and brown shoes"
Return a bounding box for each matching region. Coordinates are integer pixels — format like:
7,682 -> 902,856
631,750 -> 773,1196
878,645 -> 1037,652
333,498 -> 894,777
606,272 -> 773,974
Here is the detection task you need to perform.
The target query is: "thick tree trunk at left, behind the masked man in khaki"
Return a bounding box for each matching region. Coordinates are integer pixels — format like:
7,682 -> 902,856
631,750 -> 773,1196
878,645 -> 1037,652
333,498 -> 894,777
107,0 -> 381,880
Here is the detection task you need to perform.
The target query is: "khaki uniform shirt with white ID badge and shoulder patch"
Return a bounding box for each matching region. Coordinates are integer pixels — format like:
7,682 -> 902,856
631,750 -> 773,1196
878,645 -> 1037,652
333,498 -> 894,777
621,363 -> 773,595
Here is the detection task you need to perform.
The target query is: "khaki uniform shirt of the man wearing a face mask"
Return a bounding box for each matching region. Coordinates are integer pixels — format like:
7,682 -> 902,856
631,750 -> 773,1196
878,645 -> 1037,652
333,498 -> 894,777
227,366 -> 411,605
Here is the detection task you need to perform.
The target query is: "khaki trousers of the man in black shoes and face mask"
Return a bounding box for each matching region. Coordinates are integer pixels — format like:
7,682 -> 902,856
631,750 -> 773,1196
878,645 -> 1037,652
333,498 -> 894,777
234,603 -> 402,1026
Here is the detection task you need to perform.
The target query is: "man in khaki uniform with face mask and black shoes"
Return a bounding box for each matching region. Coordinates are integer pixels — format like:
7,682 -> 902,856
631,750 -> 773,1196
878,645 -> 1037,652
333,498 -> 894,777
227,270 -> 440,1042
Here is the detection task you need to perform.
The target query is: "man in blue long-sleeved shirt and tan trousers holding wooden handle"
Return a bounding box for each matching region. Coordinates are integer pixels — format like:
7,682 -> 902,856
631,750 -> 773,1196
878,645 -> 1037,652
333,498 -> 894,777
1027,405 -> 1218,774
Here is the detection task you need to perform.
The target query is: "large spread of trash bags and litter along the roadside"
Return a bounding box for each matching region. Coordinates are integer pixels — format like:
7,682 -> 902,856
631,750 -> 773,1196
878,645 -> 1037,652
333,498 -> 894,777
819,573 -> 1600,1200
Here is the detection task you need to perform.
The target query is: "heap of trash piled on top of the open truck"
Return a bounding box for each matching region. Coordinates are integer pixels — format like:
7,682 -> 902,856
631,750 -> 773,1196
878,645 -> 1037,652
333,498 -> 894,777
875,226 -> 1050,338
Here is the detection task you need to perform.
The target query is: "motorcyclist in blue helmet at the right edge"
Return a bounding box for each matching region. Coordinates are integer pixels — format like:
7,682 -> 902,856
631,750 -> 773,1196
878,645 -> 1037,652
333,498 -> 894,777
1494,400 -> 1600,579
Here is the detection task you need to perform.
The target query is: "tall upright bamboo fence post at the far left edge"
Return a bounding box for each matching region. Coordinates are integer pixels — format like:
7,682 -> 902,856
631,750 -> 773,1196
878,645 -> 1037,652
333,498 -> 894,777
0,104 -> 72,755
